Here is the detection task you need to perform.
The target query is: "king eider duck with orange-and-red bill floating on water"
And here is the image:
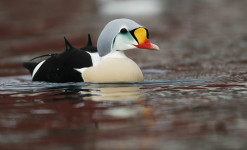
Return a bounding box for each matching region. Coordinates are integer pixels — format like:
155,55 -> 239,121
23,18 -> 159,83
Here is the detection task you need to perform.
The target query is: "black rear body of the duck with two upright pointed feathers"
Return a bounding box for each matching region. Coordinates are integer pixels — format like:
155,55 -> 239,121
23,35 -> 97,83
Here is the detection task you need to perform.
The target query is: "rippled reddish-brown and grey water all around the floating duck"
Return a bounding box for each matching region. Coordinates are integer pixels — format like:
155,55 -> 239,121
0,0 -> 247,150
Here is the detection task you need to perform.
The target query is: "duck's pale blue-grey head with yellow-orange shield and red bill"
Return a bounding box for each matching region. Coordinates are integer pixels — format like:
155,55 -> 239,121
97,19 -> 158,57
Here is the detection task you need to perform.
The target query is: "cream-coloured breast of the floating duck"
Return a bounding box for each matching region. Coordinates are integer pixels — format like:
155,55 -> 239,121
82,58 -> 143,82
